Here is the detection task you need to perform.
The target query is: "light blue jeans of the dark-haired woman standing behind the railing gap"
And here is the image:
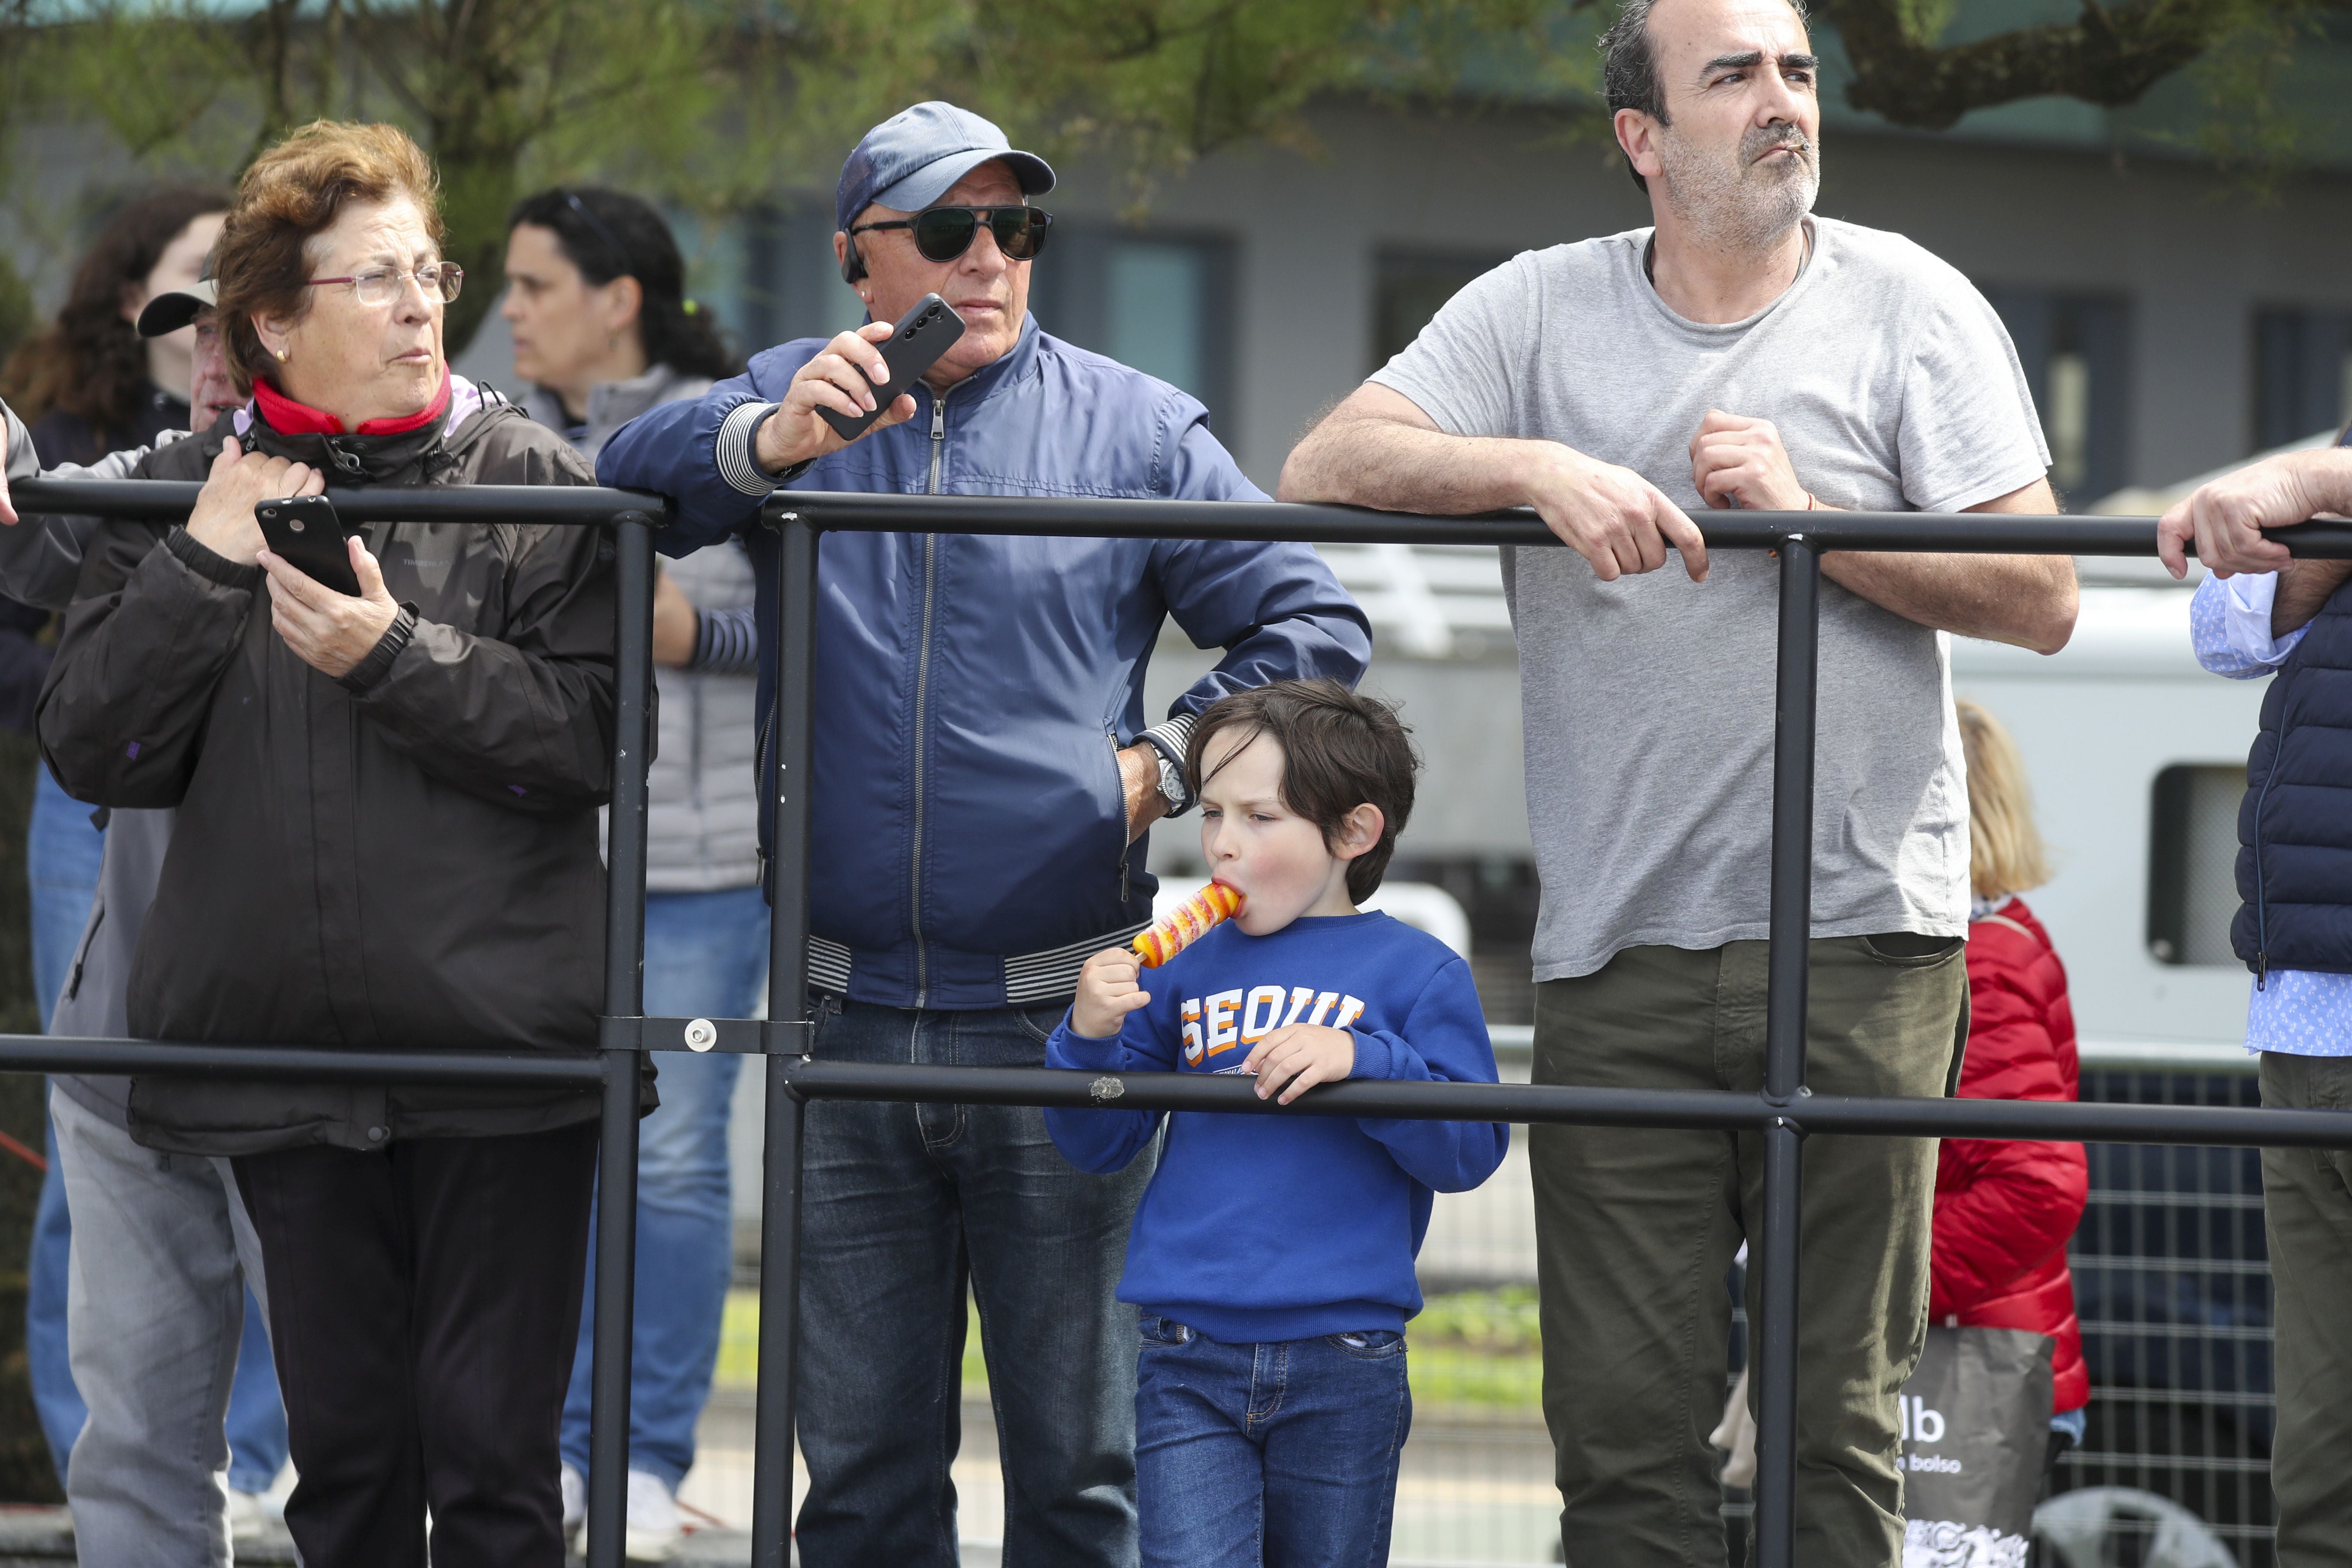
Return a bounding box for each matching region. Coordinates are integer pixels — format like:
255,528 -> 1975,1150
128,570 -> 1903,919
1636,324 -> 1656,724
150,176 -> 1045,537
562,886 -> 767,1491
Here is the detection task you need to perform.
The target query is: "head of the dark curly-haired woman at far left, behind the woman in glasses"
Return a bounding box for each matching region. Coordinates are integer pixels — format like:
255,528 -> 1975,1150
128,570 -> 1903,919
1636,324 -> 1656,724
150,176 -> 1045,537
0,190 -> 228,468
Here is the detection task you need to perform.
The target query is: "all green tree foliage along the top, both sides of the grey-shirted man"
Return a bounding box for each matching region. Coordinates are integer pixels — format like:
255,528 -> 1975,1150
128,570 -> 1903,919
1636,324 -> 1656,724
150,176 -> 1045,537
0,0 -> 2352,350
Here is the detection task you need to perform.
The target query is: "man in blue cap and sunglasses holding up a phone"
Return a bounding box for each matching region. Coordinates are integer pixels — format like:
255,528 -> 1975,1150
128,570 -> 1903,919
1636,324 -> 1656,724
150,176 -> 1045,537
597,104 -> 1371,1568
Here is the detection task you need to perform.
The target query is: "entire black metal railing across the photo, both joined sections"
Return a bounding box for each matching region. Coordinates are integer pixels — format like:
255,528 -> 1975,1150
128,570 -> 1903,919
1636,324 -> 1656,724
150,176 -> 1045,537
18,482 -> 2352,1568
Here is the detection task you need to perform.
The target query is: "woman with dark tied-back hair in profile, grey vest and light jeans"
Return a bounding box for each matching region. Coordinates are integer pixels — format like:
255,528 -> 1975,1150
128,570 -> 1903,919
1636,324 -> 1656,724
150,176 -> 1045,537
501,190 -> 748,1561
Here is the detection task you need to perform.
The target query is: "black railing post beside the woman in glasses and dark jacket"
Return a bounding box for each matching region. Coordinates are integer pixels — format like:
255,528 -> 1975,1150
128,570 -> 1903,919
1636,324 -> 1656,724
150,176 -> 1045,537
588,512 -> 654,1568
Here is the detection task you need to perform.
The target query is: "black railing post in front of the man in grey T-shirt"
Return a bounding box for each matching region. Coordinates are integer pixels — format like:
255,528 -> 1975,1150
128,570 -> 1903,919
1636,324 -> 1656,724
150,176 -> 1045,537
1752,534 -> 1820,1568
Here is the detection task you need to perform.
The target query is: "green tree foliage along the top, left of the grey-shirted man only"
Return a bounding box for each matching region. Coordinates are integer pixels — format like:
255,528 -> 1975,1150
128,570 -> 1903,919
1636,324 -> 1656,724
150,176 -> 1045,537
0,0 -> 1559,348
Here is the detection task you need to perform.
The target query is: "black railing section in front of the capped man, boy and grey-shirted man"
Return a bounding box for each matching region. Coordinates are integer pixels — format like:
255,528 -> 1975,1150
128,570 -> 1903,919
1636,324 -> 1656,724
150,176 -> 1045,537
753,494 -> 2352,1568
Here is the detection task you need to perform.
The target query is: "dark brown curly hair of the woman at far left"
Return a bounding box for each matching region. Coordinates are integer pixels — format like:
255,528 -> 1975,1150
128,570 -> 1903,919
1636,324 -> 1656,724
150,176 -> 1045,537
0,188 -> 228,435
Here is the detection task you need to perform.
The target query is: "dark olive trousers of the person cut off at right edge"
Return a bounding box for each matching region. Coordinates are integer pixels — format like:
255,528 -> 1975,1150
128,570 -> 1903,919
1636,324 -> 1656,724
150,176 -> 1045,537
2263,1051 -> 2352,1568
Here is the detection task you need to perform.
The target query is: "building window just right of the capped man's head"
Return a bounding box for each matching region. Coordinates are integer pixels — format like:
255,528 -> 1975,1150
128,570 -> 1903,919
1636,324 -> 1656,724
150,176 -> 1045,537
1030,221 -> 1235,430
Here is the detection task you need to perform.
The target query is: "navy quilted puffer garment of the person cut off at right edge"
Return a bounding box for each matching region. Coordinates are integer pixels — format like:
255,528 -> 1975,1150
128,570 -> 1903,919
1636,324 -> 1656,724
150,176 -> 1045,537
2230,583 -> 2352,978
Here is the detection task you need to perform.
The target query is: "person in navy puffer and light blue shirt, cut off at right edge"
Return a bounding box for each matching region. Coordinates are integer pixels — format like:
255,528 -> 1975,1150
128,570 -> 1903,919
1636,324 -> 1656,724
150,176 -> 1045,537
2157,428 -> 2352,1568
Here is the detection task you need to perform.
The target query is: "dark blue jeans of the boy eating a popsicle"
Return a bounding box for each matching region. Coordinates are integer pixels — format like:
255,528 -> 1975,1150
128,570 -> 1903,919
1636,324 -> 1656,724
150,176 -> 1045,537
1136,1312 -> 1414,1568
